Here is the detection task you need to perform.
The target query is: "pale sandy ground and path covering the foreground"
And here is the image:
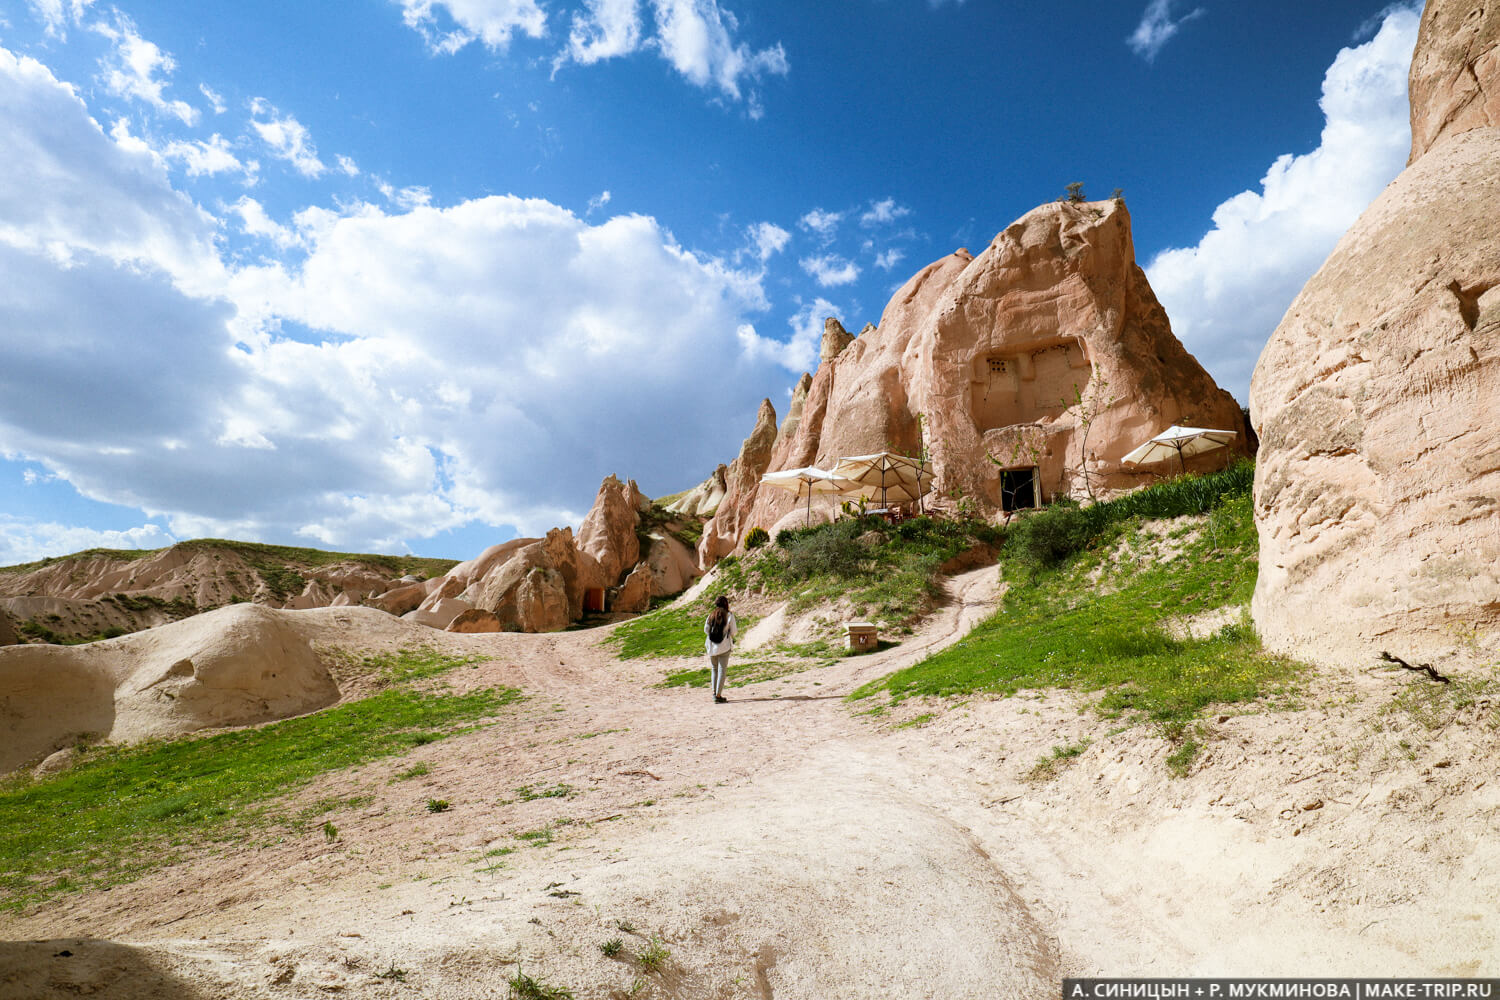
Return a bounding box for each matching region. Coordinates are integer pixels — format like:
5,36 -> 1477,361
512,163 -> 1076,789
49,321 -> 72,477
0,567 -> 1500,1000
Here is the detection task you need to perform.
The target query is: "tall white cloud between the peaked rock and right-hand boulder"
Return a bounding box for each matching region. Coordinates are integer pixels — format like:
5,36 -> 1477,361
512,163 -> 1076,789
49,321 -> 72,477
1146,7 -> 1419,400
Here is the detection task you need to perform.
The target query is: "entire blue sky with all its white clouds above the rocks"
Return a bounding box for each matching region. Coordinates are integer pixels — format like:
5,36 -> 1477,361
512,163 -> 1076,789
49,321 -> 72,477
0,0 -> 1421,565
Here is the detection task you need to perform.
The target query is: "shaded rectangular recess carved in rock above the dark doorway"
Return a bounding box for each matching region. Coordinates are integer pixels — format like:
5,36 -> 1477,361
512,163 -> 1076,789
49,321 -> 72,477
971,337 -> 1091,433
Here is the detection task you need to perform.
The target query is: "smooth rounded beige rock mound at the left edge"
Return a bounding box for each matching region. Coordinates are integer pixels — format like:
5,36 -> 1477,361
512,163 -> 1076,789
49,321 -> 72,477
0,604 -> 337,771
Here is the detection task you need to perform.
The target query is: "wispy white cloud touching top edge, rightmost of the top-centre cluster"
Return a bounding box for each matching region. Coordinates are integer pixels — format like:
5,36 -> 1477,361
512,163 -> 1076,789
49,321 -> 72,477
651,0 -> 791,100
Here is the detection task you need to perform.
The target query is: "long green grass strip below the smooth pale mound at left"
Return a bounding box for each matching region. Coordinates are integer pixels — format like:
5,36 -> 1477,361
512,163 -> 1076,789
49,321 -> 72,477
0,688 -> 522,910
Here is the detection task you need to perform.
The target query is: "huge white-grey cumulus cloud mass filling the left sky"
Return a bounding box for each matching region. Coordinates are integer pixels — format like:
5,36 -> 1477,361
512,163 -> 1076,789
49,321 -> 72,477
0,41 -> 806,558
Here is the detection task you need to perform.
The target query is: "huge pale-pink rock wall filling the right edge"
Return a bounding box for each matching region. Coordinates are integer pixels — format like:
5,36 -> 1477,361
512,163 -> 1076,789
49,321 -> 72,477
1251,0 -> 1500,664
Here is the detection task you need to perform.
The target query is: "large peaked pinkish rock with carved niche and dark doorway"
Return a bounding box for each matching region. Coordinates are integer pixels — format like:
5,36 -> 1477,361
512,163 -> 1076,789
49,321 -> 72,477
699,201 -> 1247,565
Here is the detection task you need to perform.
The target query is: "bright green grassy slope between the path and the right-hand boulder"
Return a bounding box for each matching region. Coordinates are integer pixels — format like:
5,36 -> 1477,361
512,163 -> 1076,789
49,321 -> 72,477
851,478 -> 1302,731
